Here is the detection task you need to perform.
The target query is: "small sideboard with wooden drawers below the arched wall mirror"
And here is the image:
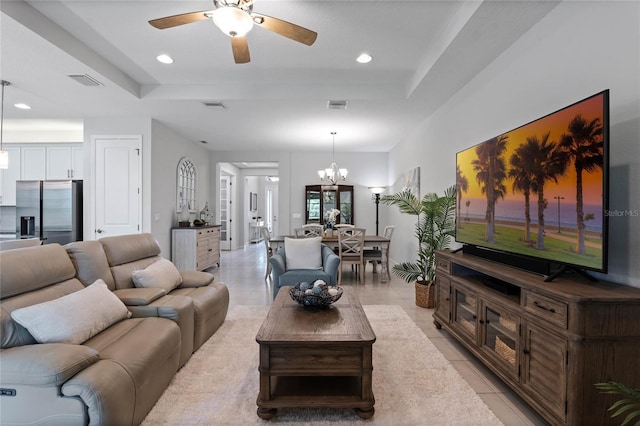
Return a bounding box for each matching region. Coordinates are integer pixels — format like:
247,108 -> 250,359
171,225 -> 220,271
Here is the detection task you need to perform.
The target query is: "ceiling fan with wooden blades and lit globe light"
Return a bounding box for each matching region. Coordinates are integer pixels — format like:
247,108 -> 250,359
149,0 -> 318,64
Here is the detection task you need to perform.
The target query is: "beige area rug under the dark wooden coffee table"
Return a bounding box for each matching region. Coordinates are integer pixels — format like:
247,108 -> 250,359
143,305 -> 502,426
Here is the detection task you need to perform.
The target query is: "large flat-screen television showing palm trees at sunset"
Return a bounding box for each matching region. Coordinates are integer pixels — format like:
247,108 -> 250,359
456,90 -> 609,281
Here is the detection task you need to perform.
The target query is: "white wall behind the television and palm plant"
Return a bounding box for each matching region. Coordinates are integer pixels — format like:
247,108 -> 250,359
387,1 -> 640,287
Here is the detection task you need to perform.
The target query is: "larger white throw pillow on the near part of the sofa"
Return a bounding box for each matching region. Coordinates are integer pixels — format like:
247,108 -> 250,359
11,280 -> 131,345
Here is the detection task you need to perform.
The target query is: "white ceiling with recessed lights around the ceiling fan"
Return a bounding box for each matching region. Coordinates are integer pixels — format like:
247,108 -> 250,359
0,0 -> 557,152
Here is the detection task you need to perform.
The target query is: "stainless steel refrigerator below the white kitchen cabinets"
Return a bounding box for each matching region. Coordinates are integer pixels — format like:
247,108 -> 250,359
16,180 -> 82,245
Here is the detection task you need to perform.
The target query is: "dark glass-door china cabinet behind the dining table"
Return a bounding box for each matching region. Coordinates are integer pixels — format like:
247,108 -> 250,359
305,185 -> 354,225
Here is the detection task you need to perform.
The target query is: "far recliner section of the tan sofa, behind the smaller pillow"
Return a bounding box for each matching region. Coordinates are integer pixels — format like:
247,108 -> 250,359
65,233 -> 229,365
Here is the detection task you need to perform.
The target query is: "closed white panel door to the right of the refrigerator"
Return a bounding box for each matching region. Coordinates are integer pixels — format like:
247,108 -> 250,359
94,136 -> 142,238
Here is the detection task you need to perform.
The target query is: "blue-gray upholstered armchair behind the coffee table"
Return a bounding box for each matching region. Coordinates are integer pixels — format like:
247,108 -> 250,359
269,244 -> 340,299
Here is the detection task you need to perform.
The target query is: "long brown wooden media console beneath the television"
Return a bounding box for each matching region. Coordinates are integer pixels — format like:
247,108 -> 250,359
433,252 -> 640,425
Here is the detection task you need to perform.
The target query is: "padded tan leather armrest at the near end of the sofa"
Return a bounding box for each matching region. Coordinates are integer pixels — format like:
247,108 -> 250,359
0,343 -> 100,387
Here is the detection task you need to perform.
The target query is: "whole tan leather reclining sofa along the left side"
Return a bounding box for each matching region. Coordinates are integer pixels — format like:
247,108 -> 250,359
0,234 -> 229,425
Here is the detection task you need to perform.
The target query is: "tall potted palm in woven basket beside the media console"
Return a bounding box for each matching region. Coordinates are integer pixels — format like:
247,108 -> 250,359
380,185 -> 456,308
